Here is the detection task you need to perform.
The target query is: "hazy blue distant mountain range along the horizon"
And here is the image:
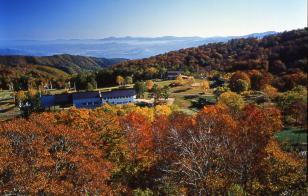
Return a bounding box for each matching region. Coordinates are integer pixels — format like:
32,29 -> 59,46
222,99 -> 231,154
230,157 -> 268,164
0,31 -> 277,59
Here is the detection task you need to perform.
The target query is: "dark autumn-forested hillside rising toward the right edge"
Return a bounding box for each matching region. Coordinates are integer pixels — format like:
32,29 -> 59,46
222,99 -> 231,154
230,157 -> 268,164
113,28 -> 308,75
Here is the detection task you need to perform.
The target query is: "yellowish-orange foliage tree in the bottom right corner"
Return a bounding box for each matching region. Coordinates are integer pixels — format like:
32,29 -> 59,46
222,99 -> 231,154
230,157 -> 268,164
249,138 -> 307,195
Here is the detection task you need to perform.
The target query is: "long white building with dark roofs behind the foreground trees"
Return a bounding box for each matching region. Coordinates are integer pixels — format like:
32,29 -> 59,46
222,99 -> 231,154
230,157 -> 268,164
41,89 -> 136,109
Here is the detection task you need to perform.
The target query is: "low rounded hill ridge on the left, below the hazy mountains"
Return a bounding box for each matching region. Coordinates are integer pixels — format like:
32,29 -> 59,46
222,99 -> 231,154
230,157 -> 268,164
0,55 -> 126,77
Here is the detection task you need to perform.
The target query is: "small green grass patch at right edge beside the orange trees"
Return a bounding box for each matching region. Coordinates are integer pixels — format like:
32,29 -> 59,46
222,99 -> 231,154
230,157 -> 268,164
276,128 -> 307,144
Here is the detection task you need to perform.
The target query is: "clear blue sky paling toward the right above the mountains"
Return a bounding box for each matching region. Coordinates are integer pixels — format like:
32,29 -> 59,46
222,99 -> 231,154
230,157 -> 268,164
0,0 -> 307,40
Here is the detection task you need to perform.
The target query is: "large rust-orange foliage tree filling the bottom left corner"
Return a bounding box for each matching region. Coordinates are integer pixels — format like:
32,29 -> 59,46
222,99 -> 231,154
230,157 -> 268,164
0,115 -> 112,195
